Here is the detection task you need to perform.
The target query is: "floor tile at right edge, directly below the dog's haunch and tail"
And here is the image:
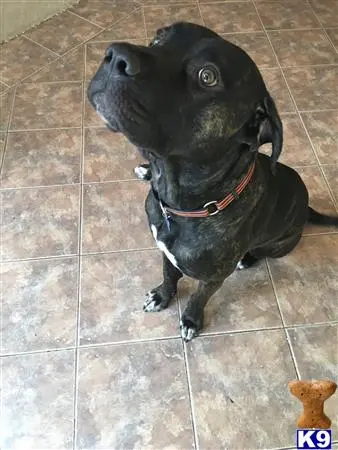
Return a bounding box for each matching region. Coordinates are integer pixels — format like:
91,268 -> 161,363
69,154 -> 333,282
269,234 -> 338,325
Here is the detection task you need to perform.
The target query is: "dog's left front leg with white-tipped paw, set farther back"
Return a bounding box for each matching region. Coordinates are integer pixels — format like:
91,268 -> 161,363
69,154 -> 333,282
143,254 -> 183,312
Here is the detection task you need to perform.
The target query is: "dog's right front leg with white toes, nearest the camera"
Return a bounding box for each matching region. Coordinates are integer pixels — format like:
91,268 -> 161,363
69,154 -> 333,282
181,280 -> 224,342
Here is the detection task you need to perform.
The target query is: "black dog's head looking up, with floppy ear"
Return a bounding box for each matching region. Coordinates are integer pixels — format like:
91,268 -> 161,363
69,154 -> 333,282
88,22 -> 283,171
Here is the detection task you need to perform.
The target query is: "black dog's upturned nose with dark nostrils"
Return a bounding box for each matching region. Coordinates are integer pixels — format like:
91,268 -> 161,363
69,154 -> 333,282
105,44 -> 140,77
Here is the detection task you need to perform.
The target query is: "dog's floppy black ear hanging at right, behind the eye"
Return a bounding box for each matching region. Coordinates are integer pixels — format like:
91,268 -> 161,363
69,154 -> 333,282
257,96 -> 283,173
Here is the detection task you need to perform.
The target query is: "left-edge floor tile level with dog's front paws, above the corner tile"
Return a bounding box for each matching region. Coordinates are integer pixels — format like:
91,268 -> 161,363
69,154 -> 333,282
0,258 -> 78,353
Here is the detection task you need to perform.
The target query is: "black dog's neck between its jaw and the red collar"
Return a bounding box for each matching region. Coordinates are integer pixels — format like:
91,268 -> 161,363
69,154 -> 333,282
144,144 -> 255,210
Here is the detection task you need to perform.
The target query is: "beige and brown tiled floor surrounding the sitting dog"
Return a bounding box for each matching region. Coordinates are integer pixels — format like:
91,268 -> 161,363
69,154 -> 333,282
0,0 -> 338,450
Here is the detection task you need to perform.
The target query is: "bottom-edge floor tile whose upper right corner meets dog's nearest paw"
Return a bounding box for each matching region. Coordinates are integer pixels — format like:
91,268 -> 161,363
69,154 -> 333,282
77,340 -> 193,450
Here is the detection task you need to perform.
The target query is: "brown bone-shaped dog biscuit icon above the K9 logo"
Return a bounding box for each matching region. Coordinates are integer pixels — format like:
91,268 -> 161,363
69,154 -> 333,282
289,380 -> 337,429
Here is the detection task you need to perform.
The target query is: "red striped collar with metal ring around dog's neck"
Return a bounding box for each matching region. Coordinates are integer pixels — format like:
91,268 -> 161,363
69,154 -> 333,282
160,163 -> 255,219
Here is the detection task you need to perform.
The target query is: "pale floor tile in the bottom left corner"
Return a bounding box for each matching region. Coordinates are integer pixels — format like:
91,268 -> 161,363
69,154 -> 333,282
0,350 -> 75,450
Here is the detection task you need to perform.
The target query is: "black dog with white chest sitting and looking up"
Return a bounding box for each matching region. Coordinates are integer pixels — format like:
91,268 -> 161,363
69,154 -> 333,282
88,23 -> 338,340
